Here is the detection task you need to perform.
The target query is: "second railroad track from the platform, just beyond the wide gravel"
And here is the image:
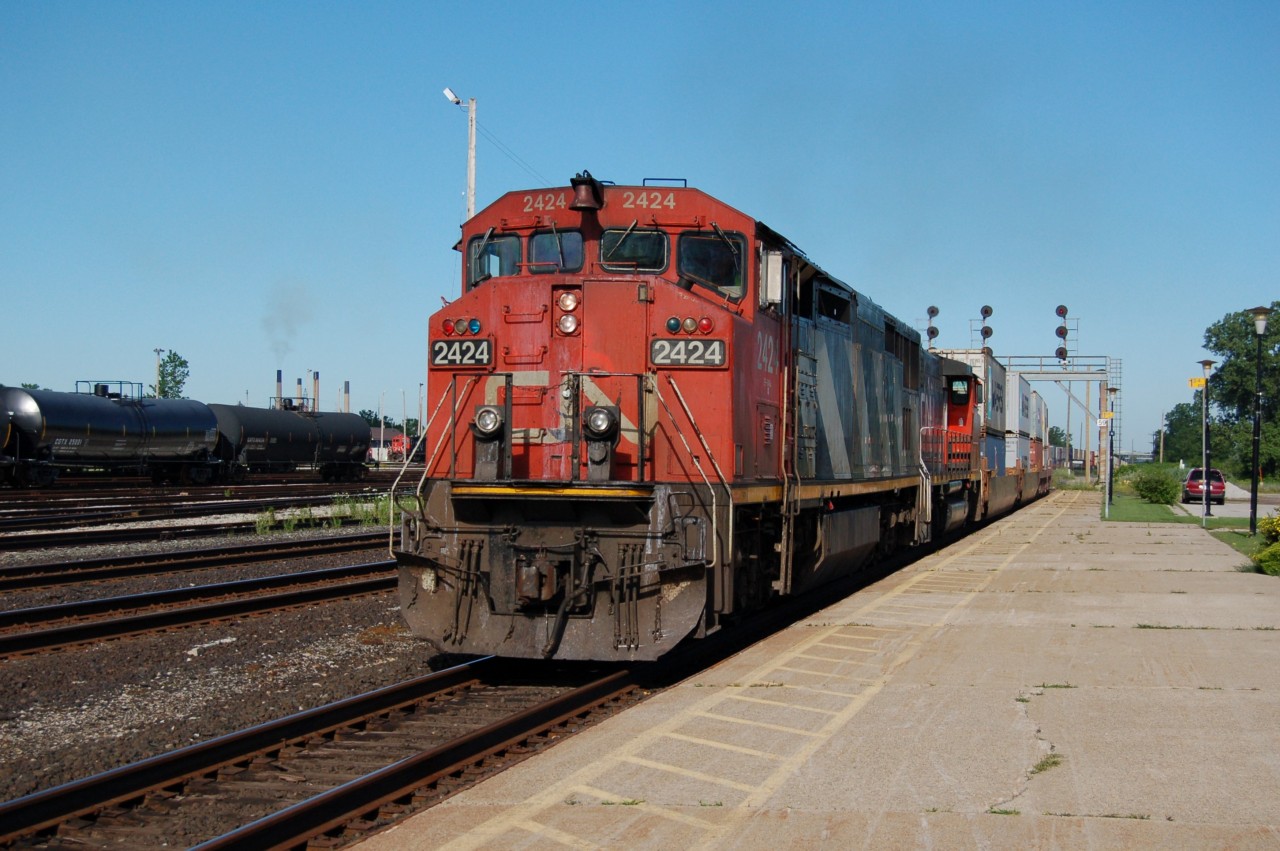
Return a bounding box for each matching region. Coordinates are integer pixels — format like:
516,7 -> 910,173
0,561 -> 397,658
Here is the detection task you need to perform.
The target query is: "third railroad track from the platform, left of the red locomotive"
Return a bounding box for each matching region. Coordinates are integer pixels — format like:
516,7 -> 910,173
0,530 -> 387,591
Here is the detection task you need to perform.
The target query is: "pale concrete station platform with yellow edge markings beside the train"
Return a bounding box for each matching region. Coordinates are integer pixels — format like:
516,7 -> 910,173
361,491 -> 1280,851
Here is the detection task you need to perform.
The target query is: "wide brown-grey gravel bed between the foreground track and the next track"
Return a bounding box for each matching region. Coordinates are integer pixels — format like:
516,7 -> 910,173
0,532 -> 448,800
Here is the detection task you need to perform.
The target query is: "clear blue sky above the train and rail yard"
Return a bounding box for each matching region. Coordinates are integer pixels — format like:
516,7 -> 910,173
0,0 -> 1280,458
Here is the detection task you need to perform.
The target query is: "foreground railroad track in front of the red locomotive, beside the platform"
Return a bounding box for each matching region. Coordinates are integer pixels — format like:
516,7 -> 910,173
0,659 -> 644,848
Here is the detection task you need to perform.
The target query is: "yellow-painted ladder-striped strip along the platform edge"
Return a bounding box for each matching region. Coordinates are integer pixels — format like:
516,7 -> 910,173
444,491 -> 1079,848
